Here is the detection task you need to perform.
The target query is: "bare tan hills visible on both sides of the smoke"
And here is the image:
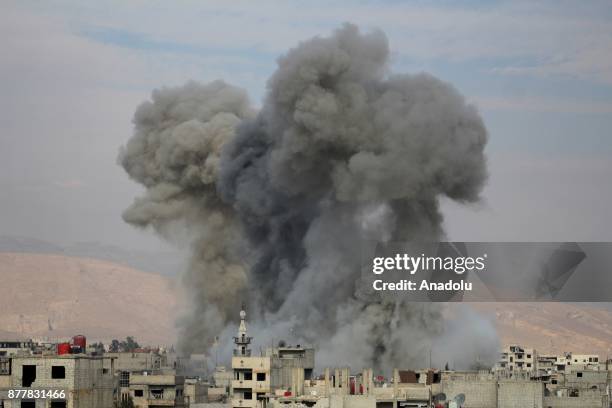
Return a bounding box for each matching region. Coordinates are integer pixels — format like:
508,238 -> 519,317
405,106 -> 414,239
0,253 -> 612,357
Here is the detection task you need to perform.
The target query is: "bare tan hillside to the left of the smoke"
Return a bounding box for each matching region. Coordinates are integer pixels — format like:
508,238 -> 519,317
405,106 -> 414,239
0,253 -> 176,344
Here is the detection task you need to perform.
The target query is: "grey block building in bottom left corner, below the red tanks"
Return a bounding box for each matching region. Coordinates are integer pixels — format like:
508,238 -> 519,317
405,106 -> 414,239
0,354 -> 113,408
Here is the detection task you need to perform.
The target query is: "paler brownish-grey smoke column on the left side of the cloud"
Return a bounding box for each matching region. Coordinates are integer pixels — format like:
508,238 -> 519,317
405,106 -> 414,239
119,81 -> 253,342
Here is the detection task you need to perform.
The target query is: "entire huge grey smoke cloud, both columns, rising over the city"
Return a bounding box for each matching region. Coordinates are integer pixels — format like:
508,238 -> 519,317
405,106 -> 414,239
119,25 -> 496,367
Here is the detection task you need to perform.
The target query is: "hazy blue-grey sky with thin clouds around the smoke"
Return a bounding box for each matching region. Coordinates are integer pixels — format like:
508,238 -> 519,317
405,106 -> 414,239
0,0 -> 612,248
